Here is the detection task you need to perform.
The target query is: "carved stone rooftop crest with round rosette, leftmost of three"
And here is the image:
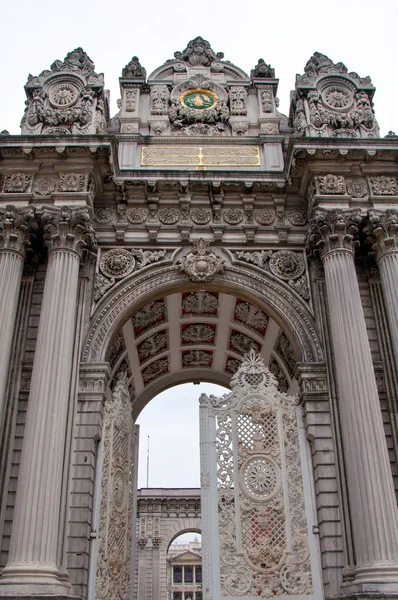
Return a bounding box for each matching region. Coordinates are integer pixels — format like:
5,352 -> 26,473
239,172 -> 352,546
21,48 -> 108,135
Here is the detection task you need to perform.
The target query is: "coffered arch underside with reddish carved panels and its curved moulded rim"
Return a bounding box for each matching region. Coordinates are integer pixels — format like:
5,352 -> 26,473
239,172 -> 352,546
83,265 -> 323,416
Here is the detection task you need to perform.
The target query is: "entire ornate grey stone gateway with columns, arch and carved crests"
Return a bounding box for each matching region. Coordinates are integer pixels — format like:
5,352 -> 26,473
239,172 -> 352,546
0,37 -> 398,600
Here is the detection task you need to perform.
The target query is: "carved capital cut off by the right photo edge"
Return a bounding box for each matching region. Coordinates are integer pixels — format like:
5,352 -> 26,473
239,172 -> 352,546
365,208 -> 398,259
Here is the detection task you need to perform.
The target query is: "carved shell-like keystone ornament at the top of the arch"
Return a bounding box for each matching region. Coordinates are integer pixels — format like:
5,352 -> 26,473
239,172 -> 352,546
177,238 -> 225,281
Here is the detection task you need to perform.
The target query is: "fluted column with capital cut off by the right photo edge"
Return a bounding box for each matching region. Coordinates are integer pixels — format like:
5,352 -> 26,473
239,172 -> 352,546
367,209 -> 398,369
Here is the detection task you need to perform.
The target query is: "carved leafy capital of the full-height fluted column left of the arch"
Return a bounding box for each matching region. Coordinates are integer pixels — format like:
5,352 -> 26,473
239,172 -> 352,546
41,206 -> 97,256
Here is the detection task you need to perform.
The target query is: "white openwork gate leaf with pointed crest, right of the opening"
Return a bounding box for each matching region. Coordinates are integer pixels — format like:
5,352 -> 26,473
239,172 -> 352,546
200,350 -> 318,599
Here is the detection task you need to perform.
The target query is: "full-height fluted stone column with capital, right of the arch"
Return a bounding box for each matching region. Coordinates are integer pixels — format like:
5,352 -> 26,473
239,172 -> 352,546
309,210 -> 398,598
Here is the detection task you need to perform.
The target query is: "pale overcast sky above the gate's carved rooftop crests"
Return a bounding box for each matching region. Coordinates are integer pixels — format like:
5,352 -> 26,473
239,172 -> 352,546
0,0 -> 398,135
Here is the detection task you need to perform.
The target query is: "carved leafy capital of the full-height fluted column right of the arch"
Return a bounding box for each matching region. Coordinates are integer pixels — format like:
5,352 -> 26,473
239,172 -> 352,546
307,209 -> 362,259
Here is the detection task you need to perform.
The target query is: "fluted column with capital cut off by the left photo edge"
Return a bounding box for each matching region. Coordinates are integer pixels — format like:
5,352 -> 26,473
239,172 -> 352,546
0,206 -> 29,430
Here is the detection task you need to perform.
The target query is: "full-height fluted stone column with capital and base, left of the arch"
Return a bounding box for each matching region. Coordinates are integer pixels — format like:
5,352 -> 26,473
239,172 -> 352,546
0,208 -> 93,597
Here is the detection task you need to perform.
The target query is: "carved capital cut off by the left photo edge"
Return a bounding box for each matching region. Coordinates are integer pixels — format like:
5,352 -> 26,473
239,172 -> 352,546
0,204 -> 34,255
